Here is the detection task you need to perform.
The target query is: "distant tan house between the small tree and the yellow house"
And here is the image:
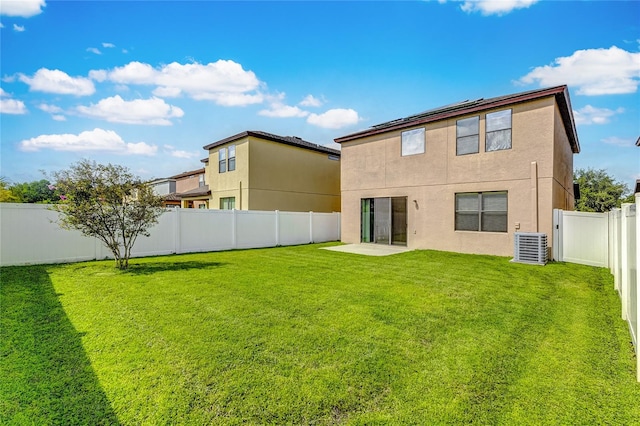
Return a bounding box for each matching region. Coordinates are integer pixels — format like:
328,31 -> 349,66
150,168 -> 208,208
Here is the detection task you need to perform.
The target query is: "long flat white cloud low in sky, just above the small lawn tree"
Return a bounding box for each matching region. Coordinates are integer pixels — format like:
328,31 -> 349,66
19,128 -> 158,155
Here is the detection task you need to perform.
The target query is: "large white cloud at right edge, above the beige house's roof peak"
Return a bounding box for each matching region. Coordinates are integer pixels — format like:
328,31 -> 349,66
519,46 -> 640,96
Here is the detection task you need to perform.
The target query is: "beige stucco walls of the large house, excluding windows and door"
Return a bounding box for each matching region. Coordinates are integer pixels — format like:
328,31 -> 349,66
341,87 -> 573,256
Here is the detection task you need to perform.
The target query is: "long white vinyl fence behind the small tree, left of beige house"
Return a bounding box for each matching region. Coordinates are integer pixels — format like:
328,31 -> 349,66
0,203 -> 340,266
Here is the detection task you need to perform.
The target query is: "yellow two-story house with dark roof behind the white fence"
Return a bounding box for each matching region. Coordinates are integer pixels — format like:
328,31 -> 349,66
203,131 -> 340,212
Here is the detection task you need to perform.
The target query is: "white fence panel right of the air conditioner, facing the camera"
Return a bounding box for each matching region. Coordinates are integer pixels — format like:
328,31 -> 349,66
557,211 -> 609,267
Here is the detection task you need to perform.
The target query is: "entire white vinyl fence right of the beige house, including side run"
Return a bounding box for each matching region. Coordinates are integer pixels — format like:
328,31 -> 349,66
553,194 -> 640,381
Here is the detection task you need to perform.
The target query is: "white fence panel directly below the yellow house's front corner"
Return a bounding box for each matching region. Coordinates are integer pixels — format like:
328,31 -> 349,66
235,210 -> 278,248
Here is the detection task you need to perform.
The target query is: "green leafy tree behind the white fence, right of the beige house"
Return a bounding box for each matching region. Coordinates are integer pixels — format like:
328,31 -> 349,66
573,168 -> 629,213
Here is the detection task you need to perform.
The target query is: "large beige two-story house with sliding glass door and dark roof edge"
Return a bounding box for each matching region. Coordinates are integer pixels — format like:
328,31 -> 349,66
335,86 -> 580,256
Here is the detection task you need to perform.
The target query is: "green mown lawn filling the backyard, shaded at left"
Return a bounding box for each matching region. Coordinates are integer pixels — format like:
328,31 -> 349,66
0,244 -> 640,425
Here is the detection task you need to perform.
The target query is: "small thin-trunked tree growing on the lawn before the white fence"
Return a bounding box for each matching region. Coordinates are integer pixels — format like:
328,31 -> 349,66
51,160 -> 165,269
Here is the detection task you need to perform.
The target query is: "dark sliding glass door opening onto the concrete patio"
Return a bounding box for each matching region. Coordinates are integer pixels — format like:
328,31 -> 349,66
360,197 -> 407,246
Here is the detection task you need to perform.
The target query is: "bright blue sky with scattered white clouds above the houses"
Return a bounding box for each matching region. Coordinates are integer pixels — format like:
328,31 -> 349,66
0,0 -> 640,187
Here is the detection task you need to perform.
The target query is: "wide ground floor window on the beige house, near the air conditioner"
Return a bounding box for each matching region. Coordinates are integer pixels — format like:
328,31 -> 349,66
455,191 -> 507,232
